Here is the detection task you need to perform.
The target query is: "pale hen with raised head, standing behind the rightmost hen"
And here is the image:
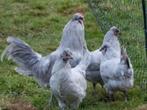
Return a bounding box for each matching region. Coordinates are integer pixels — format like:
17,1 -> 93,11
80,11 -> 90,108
86,26 -> 120,92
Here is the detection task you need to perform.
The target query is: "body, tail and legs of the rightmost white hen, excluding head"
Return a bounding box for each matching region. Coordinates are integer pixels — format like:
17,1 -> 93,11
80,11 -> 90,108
100,49 -> 134,101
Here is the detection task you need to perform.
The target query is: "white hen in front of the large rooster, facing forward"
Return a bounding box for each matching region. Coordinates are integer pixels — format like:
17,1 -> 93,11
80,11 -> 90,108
50,49 -> 90,110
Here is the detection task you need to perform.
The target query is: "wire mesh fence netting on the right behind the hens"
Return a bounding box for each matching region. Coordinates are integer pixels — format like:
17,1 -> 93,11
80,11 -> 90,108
87,0 -> 147,90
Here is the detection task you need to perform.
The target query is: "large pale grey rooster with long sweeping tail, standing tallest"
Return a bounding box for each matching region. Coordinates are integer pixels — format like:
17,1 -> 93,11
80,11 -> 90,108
1,13 -> 87,87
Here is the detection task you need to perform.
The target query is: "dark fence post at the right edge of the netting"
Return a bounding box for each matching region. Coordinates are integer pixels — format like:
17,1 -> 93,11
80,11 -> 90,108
142,0 -> 147,57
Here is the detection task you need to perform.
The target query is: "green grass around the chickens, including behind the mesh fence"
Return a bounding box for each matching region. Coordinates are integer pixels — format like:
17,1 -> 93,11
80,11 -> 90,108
0,0 -> 147,110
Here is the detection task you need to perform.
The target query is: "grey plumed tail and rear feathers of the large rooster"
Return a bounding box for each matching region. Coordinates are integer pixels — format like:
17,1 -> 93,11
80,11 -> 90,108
1,37 -> 56,85
